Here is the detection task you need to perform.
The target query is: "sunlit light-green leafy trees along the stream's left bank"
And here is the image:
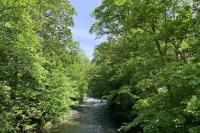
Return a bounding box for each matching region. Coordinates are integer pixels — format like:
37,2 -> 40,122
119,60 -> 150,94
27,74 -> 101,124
0,0 -> 88,132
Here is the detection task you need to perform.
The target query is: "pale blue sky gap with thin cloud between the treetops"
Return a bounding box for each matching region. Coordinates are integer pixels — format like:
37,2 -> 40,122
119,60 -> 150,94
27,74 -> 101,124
70,0 -> 105,60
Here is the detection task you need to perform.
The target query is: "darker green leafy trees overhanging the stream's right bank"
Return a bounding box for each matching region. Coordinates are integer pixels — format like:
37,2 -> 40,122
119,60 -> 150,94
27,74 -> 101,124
89,0 -> 200,133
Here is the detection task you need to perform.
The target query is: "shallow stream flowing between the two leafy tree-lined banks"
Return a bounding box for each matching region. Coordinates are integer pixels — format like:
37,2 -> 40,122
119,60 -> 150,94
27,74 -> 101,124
48,98 -> 121,133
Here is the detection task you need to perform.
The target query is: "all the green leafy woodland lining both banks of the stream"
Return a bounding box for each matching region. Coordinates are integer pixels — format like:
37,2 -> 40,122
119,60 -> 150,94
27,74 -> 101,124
0,0 -> 200,133
